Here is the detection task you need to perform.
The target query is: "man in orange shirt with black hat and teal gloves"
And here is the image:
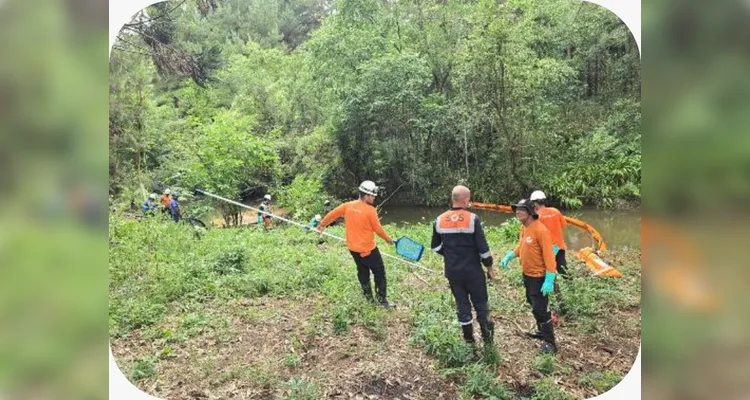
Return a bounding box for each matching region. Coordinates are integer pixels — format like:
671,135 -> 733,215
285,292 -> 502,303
500,199 -> 557,353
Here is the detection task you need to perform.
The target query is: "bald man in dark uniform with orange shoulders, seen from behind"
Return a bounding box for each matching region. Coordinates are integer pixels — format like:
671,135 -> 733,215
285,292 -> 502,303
430,185 -> 495,346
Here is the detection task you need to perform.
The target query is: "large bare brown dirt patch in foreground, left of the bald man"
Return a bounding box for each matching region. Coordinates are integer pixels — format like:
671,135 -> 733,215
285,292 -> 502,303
112,299 -> 464,400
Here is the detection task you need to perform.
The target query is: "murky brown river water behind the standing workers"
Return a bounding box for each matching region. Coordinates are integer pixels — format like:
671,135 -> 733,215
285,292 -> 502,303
380,205 -> 641,250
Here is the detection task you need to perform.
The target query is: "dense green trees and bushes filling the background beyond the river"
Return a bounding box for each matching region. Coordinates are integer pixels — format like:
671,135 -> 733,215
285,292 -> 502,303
110,0 -> 641,212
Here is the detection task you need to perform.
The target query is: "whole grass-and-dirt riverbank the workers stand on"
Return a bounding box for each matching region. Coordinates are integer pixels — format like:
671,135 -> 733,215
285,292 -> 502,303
109,217 -> 640,399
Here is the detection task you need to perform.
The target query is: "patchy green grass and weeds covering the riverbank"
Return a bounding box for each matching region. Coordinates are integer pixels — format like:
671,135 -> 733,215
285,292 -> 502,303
109,212 -> 640,400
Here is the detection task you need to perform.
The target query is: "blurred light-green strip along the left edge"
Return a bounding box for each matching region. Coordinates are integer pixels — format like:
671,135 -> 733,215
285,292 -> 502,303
0,0 -> 108,399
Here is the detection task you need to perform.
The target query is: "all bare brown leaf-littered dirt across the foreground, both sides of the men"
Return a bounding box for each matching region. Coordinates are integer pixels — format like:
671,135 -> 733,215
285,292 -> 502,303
111,248 -> 641,400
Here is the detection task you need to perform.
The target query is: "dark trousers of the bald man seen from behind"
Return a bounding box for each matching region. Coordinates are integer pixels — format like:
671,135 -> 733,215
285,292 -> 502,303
448,270 -> 490,325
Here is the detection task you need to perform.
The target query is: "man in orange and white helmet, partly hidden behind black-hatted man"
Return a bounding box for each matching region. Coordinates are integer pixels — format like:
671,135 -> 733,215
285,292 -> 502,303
529,190 -> 570,315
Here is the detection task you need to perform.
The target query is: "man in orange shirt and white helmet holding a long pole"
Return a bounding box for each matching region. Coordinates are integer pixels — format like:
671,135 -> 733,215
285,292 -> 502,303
316,181 -> 394,308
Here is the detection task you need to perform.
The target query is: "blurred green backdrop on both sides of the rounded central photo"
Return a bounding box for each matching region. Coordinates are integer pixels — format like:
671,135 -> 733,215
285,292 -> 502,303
0,0 -> 750,399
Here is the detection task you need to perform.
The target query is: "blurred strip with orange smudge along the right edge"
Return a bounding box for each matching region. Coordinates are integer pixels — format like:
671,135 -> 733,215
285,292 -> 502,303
641,0 -> 750,399
